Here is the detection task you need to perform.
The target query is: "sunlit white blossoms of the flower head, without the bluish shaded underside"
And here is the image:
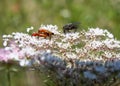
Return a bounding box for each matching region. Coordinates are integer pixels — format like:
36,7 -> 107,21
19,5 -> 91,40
3,25 -> 120,65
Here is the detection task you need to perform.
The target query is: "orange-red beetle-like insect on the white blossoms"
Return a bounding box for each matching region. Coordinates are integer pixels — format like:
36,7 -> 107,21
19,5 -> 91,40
32,29 -> 54,39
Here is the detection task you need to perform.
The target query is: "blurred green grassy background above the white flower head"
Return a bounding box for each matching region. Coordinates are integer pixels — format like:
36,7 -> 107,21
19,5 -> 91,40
0,0 -> 120,86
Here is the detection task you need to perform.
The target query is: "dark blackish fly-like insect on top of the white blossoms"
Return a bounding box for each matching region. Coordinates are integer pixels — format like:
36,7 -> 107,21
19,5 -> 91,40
63,22 -> 80,34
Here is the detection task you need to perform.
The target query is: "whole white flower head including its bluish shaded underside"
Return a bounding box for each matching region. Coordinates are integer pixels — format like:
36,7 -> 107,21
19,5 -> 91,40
0,25 -> 120,86
